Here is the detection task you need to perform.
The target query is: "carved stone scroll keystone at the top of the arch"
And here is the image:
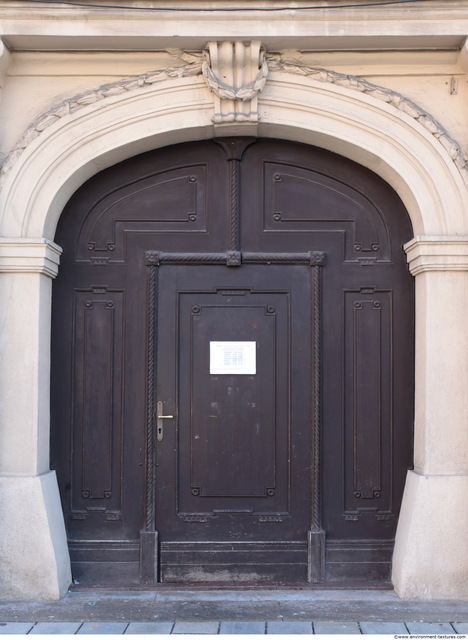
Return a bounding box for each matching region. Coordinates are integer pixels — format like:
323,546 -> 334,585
202,42 -> 268,124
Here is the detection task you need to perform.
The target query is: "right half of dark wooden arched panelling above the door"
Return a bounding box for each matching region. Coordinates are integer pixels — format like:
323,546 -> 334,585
242,140 -> 404,263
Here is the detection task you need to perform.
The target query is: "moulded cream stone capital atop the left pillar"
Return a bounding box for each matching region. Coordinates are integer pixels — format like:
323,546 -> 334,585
0,238 -> 62,278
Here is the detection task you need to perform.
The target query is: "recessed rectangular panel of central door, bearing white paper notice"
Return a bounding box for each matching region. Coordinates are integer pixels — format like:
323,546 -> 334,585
179,296 -> 289,509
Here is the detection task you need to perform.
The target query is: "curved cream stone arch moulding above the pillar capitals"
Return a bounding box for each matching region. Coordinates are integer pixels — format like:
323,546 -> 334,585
0,53 -> 468,239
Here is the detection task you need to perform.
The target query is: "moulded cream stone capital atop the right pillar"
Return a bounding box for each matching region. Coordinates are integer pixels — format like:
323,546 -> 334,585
404,236 -> 468,276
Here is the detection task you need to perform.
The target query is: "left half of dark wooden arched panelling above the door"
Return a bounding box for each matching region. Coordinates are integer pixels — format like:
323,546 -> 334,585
62,142 -> 228,264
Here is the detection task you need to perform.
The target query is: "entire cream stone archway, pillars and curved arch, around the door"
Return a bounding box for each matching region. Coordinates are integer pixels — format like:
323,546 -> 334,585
0,62 -> 468,598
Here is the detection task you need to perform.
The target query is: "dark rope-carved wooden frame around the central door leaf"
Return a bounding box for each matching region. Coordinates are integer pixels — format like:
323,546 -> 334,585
140,250 -> 325,584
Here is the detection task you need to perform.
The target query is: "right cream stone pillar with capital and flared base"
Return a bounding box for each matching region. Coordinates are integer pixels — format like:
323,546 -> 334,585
393,236 -> 468,598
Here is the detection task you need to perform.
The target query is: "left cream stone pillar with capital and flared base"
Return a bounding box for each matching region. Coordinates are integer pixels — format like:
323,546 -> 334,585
0,238 -> 70,599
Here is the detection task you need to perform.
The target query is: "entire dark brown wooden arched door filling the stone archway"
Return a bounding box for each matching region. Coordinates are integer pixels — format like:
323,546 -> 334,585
52,139 -> 414,584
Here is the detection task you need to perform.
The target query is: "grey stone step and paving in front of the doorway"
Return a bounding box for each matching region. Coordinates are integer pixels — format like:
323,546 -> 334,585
0,589 -> 468,638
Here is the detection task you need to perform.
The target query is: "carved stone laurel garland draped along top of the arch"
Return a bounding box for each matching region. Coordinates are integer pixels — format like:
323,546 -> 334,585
0,50 -> 468,186
